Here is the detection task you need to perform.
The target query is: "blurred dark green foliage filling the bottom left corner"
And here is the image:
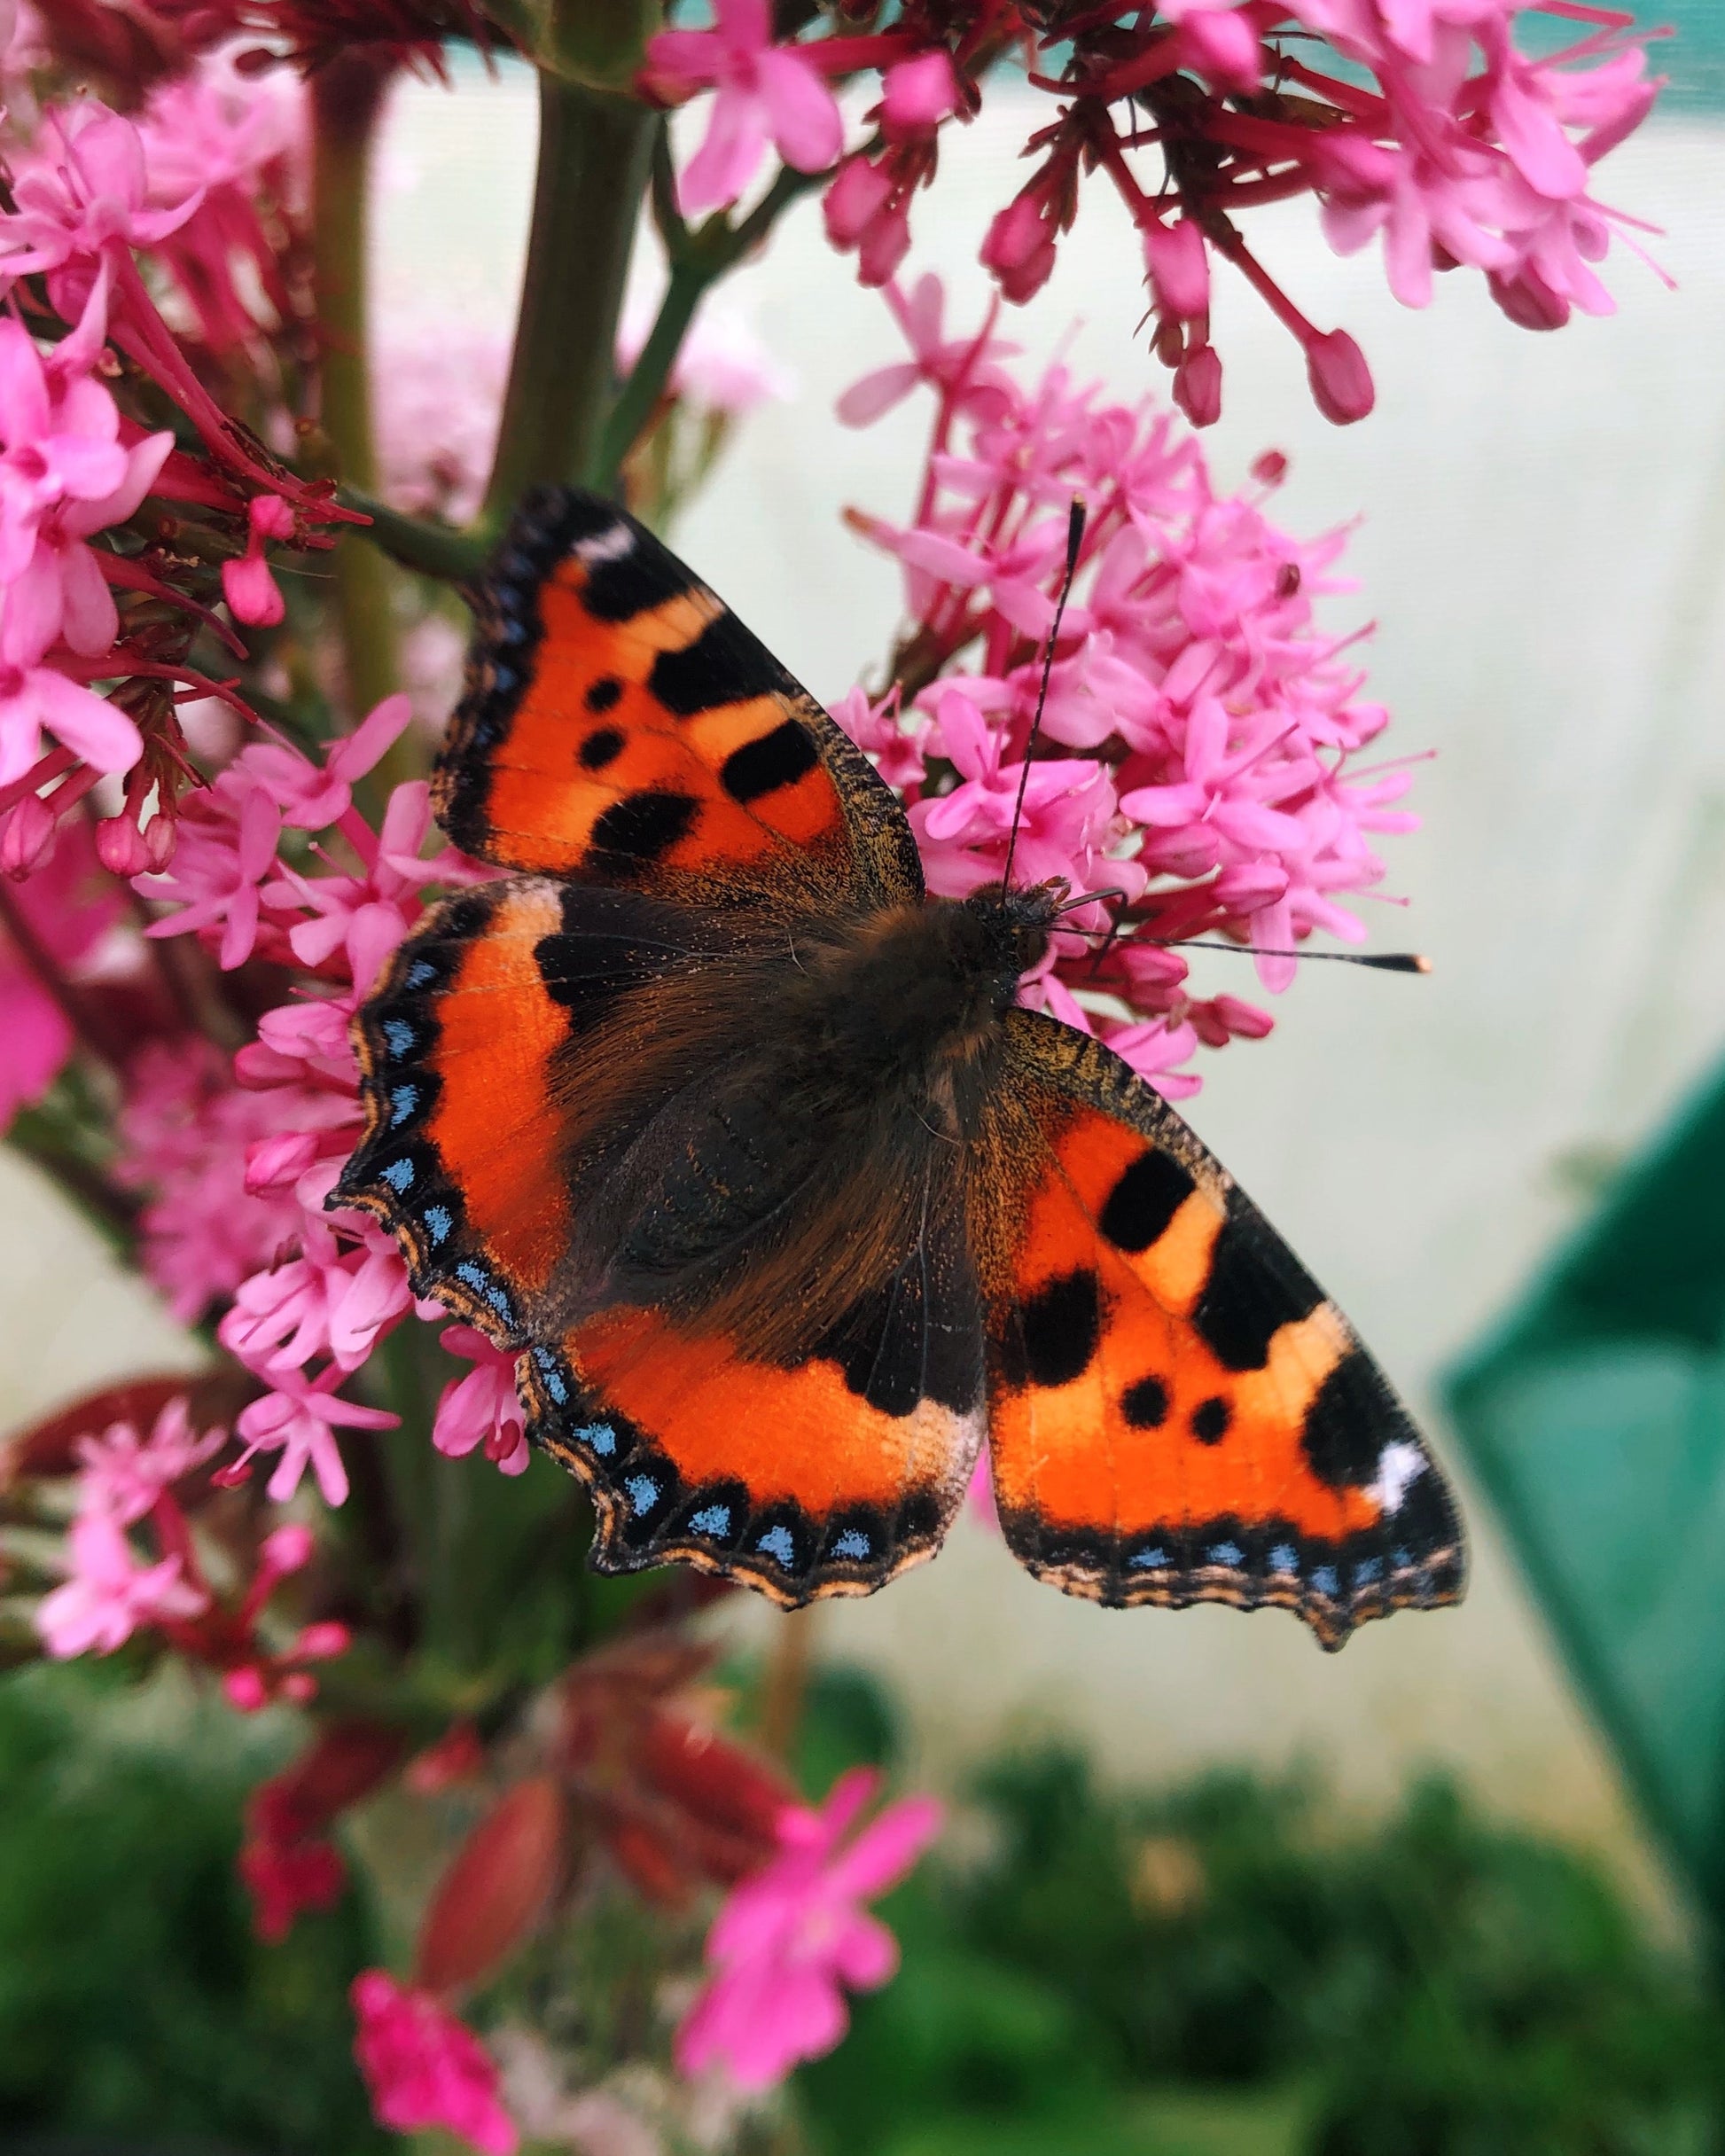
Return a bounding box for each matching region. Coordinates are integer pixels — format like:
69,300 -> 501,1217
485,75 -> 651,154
0,1665 -> 381,2156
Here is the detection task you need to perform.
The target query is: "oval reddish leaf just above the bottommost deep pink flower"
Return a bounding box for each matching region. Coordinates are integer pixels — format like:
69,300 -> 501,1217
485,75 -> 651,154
414,1775 -> 565,1992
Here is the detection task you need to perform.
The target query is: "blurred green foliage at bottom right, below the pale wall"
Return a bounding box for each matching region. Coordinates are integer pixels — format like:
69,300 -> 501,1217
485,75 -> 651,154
800,1690 -> 1725,2156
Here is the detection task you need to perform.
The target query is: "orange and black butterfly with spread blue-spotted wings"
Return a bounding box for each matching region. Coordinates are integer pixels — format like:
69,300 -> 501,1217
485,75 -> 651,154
340,489 -> 1464,1647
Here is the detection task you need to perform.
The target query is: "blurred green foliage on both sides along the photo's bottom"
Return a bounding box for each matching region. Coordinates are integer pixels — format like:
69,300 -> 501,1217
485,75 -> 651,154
0,1667 -> 1725,2156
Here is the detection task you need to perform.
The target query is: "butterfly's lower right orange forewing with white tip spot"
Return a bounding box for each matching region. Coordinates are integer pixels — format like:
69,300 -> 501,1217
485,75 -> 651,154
983,1012 -> 1464,1647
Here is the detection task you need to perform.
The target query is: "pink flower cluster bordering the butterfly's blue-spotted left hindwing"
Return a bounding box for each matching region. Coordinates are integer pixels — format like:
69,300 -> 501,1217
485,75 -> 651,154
121,697 -> 527,1505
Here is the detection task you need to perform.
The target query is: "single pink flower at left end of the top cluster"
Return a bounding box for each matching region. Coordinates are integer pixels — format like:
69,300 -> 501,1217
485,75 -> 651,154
647,0 -> 846,215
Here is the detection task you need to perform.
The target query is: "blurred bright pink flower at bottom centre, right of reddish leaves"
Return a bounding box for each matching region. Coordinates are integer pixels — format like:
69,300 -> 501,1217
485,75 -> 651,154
677,1768 -> 941,2090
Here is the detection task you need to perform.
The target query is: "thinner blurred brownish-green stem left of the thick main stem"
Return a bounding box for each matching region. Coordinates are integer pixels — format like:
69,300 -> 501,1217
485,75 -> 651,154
310,48 -> 408,732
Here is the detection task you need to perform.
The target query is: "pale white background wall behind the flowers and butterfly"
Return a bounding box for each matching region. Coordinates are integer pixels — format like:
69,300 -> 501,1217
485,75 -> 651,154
0,54 -> 1725,1905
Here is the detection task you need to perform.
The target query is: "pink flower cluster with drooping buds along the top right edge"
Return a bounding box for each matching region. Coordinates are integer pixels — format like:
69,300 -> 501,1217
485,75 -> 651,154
640,0 -> 1659,425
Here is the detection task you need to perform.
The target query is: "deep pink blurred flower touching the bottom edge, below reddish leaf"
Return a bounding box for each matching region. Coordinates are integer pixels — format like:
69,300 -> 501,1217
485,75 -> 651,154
347,1968 -> 519,2156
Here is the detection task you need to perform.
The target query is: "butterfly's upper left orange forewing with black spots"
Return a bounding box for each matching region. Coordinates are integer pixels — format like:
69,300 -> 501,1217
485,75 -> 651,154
433,488 -> 923,908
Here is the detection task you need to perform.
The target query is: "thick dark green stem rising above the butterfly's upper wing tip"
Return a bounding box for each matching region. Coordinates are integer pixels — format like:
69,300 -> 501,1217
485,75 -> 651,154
483,74 -> 658,535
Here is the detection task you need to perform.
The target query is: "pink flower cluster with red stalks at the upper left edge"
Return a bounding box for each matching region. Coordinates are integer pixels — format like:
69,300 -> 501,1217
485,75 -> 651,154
0,82 -> 351,875
